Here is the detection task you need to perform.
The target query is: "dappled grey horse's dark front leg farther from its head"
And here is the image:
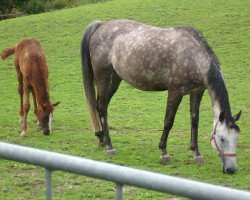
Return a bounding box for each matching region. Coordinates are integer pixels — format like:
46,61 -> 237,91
159,91 -> 183,164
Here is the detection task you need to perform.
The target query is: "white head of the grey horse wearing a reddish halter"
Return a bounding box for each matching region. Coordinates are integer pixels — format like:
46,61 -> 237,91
211,111 -> 241,174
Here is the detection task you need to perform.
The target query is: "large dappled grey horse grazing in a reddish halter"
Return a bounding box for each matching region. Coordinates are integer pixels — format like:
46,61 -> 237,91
81,19 -> 241,173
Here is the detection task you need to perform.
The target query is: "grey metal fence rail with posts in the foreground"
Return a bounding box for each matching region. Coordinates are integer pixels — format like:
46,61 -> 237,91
0,142 -> 250,200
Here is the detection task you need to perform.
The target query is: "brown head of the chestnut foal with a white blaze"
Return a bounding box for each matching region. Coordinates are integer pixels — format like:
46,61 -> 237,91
38,102 -> 60,135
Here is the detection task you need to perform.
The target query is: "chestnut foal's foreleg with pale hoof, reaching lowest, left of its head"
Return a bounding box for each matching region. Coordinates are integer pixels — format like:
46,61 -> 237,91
20,83 -> 30,136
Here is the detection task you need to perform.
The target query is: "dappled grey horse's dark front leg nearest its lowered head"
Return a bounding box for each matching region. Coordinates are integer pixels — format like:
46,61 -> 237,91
190,91 -> 204,163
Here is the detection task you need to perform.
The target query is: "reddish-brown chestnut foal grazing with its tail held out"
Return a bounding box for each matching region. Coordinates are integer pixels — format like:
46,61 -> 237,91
1,39 -> 59,136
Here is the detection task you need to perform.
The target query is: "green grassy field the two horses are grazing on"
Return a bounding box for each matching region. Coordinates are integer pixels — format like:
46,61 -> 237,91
0,0 -> 250,200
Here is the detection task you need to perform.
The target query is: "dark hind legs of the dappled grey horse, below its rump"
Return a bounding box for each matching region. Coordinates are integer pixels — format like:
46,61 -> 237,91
96,72 -> 121,154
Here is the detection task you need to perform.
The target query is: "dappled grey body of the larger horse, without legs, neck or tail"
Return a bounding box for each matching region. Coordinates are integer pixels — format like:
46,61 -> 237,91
90,20 -> 210,92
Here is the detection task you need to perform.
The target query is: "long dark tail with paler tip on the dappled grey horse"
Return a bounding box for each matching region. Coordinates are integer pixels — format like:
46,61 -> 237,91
81,22 -> 102,132
